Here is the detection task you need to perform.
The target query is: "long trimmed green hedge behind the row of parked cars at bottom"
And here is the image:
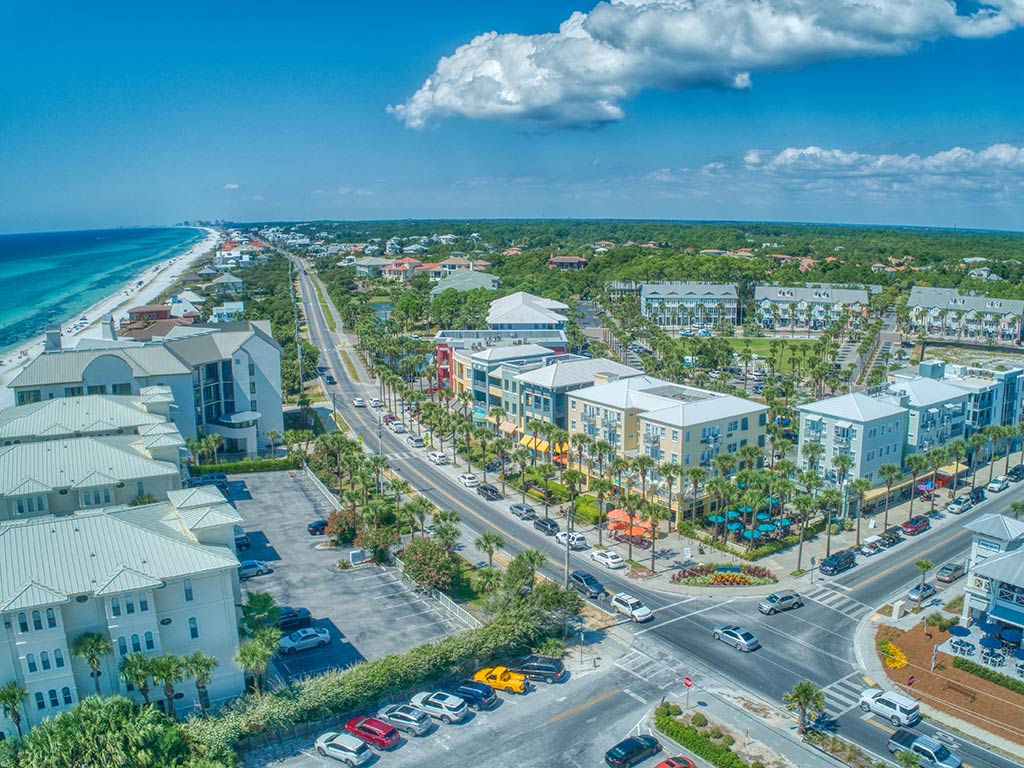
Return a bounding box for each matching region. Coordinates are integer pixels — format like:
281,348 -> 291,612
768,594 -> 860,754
182,620 -> 540,760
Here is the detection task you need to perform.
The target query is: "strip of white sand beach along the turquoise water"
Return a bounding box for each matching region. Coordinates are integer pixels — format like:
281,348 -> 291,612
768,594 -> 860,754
0,226 -> 220,408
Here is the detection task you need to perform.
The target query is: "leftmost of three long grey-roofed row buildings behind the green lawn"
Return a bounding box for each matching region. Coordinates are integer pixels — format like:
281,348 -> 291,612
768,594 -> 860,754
640,283 -> 739,332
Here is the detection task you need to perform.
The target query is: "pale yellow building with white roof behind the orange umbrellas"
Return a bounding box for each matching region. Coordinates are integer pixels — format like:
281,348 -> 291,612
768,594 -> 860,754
567,374 -> 768,479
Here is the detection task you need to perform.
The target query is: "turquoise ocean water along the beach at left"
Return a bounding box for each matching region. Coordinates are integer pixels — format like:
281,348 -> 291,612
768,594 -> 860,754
0,227 -> 205,351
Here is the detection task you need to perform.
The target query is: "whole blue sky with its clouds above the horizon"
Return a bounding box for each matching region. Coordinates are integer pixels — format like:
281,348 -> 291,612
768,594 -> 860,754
0,0 -> 1024,232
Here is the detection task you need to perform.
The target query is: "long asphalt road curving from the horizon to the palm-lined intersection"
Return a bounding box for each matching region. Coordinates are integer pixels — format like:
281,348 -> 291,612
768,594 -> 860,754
299,259 -> 1024,768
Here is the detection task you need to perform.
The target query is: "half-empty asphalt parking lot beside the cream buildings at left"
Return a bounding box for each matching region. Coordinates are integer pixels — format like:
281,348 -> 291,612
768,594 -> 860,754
230,472 -> 466,679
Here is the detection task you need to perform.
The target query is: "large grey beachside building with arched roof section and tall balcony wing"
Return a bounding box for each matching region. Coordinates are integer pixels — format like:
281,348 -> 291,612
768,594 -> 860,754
10,321 -> 284,456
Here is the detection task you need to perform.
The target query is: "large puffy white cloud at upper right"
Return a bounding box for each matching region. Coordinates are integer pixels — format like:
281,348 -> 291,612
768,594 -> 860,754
388,0 -> 1024,128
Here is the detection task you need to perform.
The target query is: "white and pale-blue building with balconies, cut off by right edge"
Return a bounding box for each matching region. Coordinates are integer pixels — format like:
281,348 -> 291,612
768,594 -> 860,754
961,513 -> 1024,631
